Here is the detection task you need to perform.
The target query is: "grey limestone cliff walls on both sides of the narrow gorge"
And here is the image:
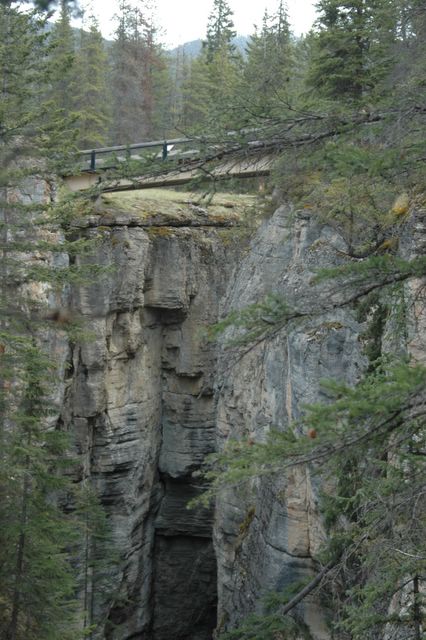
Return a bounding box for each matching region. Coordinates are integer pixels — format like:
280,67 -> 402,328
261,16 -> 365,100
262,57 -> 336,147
55,191 -> 424,640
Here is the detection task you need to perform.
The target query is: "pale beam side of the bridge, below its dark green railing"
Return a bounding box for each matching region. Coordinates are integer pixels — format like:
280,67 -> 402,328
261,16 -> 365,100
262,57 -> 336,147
65,156 -> 273,192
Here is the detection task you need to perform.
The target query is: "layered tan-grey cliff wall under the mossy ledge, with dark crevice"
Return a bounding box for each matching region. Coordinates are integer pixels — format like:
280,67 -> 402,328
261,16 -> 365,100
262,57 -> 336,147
62,201 -> 245,640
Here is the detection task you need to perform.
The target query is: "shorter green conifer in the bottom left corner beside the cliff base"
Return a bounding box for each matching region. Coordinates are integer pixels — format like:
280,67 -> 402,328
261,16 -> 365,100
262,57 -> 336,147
0,336 -> 77,640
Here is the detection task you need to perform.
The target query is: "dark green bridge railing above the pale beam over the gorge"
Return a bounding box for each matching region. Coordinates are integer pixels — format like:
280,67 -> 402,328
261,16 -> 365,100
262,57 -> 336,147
78,138 -> 200,171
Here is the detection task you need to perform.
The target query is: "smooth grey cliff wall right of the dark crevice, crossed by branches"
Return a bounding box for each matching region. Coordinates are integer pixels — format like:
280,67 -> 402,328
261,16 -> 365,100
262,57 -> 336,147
215,207 -> 365,640
